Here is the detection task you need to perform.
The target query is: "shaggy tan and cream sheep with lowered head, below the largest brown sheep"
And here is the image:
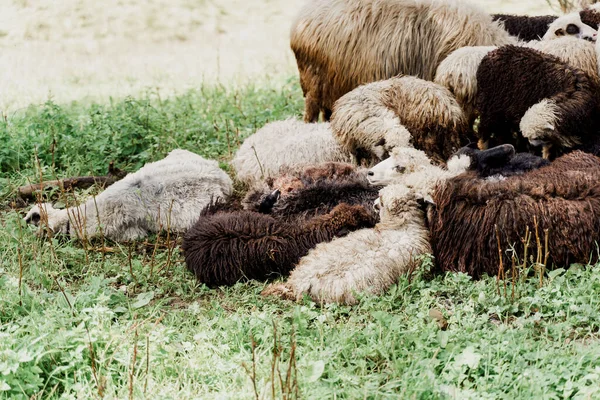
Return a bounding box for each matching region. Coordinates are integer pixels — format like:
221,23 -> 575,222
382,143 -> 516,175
331,76 -> 470,163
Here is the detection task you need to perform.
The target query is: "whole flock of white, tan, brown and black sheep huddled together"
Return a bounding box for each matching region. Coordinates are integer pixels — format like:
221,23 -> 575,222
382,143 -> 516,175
25,0 -> 600,304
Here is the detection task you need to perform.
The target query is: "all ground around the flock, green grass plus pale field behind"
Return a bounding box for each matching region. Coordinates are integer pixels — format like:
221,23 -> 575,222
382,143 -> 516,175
0,0 -> 600,399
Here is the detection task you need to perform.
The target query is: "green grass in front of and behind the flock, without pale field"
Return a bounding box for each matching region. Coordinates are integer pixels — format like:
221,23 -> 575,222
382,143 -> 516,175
0,80 -> 600,399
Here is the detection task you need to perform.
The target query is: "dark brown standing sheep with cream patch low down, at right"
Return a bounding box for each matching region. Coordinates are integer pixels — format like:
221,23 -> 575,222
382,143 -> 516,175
476,45 -> 600,158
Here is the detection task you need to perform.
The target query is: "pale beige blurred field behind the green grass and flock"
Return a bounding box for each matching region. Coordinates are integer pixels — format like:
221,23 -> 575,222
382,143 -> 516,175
0,0 -> 590,114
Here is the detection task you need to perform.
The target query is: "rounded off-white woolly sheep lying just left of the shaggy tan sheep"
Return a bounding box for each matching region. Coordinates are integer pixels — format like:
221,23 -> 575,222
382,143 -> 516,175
231,118 -> 354,185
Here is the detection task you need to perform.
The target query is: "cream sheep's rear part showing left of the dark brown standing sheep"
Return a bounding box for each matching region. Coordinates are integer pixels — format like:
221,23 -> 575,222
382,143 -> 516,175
434,46 -> 497,127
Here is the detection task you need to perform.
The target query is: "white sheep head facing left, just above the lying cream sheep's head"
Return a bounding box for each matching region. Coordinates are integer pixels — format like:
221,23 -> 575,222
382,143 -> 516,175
367,147 -> 431,185
